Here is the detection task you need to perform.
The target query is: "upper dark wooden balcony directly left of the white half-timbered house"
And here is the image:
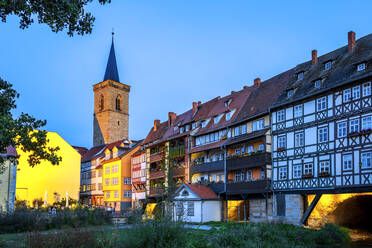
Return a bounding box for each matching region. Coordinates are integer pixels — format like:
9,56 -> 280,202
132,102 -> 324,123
226,152 -> 271,171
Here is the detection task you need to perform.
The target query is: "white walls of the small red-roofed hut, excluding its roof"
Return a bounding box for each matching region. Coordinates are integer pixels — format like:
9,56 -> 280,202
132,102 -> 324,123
173,185 -> 222,223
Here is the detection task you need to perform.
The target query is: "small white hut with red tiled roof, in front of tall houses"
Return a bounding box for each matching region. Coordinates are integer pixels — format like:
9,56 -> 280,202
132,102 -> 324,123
173,184 -> 222,222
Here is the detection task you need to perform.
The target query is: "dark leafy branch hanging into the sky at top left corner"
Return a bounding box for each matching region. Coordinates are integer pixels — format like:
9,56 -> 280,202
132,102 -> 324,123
0,0 -> 111,36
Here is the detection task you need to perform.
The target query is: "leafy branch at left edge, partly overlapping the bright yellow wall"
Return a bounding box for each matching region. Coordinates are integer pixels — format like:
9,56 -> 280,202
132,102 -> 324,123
0,79 -> 62,167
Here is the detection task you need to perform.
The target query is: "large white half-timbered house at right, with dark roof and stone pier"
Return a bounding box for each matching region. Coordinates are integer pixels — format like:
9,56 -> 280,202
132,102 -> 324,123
271,32 -> 372,223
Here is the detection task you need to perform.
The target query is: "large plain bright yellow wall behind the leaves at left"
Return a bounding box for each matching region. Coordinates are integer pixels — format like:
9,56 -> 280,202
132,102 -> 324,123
16,132 -> 81,206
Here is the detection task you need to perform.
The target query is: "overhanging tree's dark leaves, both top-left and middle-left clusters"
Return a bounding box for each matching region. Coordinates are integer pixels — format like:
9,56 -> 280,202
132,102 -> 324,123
0,0 -> 111,167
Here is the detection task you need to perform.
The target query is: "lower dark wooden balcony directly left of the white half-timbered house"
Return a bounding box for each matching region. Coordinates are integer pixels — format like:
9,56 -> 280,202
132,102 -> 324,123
226,179 -> 271,194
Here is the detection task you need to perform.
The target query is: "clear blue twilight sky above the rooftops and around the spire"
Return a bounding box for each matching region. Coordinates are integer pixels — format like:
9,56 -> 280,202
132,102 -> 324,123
0,0 -> 372,147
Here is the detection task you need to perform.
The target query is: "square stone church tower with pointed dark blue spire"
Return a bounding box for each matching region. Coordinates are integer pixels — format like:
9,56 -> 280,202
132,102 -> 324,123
93,33 -> 130,146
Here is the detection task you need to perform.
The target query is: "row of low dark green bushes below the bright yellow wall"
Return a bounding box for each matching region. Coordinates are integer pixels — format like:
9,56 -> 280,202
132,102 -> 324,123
0,208 -> 112,233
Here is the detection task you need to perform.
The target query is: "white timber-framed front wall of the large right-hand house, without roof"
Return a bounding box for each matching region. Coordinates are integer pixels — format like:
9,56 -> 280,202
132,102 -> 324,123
271,82 -> 372,191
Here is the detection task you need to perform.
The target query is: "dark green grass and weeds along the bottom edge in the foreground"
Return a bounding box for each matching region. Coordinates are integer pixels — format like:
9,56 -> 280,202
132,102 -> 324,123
0,221 -> 350,248
